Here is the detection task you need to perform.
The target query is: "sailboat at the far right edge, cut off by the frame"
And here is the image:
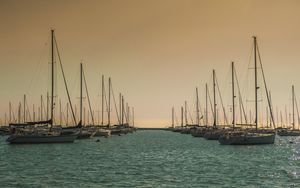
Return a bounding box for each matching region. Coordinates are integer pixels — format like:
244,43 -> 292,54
277,85 -> 300,136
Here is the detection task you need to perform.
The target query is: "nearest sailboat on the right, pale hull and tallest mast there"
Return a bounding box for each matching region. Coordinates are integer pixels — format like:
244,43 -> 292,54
219,37 -> 275,145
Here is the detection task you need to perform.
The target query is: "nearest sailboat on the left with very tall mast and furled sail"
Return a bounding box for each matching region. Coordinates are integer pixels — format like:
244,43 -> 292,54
7,30 -> 77,144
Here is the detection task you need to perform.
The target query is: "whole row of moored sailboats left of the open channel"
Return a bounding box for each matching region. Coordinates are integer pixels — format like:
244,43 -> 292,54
0,30 -> 135,144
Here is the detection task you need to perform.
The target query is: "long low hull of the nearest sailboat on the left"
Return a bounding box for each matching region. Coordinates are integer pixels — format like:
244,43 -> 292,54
6,135 -> 77,144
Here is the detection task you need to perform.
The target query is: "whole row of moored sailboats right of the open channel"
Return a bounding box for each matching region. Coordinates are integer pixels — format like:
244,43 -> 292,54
169,37 -> 300,145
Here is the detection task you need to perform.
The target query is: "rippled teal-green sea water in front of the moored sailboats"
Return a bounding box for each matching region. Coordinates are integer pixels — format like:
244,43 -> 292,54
0,131 -> 300,188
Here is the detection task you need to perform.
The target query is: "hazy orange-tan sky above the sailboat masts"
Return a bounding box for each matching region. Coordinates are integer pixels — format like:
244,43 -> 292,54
0,0 -> 300,126
